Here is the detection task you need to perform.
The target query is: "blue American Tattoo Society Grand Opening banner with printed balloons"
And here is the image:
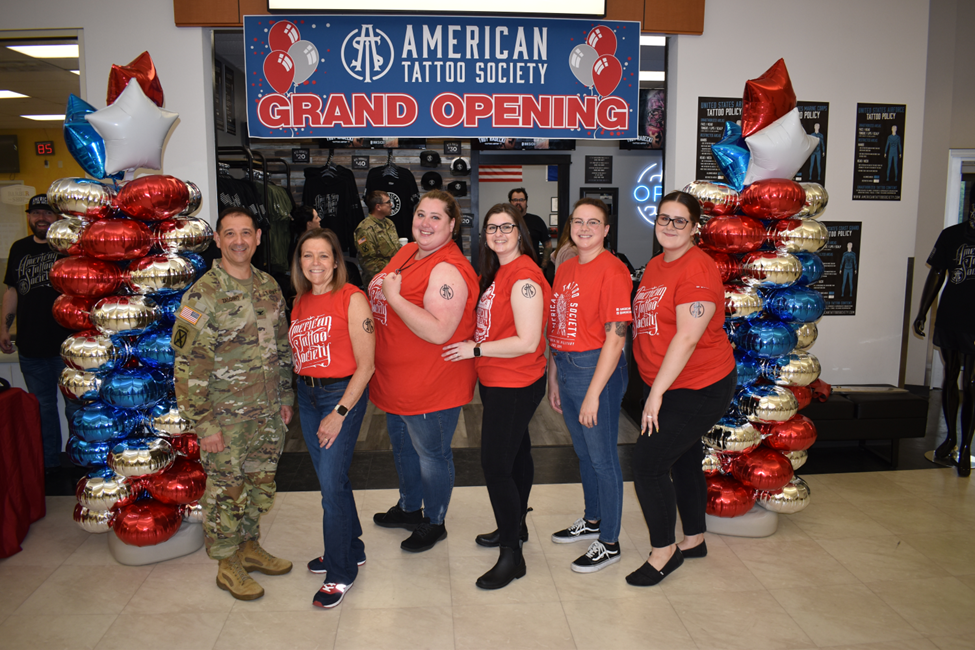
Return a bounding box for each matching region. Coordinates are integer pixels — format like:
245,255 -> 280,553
244,15 -> 640,140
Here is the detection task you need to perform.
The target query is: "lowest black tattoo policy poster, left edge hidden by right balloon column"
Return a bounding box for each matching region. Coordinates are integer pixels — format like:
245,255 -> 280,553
812,221 -> 861,316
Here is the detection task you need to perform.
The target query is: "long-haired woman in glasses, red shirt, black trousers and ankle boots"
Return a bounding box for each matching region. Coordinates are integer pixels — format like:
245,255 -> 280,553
443,203 -> 552,589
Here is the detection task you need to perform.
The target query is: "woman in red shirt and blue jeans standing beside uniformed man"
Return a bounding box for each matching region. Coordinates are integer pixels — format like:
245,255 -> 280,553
288,228 -> 376,608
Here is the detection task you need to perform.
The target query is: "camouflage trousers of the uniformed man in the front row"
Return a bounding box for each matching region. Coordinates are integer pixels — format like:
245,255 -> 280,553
200,413 -> 288,560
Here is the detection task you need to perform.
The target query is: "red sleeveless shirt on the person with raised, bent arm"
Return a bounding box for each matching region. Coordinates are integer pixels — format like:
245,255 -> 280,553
368,242 -> 478,415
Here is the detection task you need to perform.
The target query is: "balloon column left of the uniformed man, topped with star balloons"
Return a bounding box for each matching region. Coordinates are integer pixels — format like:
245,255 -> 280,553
47,53 -> 213,546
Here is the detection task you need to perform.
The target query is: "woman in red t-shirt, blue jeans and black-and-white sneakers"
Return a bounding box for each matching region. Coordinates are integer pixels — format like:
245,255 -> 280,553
548,198 -> 633,573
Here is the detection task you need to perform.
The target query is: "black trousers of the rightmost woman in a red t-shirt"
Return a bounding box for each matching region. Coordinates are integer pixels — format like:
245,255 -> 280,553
633,370 -> 738,548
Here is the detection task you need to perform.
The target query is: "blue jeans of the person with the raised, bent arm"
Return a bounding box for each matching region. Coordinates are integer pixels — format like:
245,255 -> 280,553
386,406 -> 460,525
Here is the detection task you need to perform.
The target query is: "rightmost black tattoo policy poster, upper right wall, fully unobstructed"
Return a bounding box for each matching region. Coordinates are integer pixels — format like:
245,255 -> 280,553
853,104 -> 907,201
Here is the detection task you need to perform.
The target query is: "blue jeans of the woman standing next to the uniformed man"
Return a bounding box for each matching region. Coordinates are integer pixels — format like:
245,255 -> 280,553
298,379 -> 369,585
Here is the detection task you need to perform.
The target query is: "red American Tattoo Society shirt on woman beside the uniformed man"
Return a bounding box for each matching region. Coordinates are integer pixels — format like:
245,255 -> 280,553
288,284 -> 365,378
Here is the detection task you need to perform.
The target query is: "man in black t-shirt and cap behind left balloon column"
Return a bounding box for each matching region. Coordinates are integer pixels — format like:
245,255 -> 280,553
0,194 -> 78,473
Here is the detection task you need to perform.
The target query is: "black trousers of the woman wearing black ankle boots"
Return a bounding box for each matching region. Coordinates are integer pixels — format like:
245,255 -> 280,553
480,375 -> 545,548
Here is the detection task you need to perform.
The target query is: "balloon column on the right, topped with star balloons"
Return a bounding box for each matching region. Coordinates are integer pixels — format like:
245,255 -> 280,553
684,59 -> 828,517
